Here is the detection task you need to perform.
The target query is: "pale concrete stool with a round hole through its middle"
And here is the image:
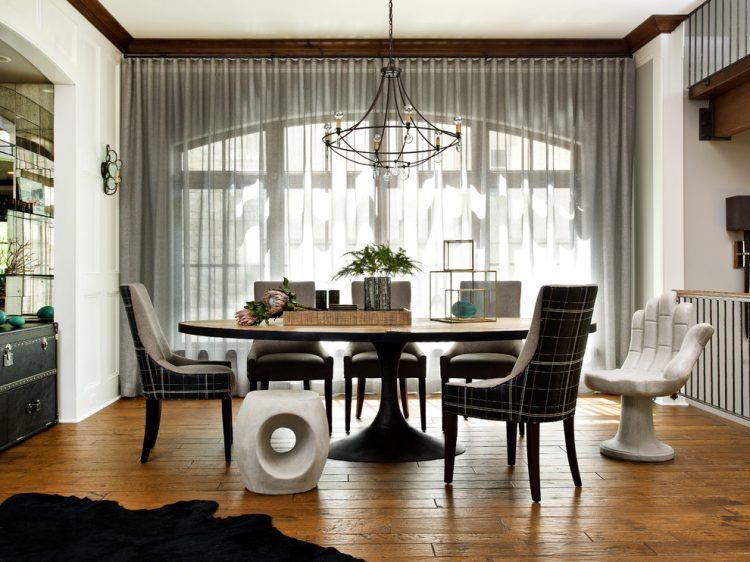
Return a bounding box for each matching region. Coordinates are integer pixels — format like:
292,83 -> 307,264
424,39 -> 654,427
234,390 -> 330,494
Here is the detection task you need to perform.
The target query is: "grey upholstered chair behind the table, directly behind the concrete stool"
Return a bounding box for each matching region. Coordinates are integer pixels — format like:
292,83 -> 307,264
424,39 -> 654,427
247,281 -> 333,432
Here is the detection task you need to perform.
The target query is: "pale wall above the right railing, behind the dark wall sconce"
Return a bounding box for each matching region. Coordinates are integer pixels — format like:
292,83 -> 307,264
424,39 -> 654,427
684,99 -> 750,292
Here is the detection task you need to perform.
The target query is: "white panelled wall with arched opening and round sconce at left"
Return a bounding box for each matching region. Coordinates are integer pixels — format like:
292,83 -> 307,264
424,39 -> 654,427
0,0 -> 121,421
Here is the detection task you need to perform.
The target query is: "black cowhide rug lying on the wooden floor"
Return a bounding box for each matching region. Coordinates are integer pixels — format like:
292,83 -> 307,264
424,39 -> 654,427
0,494 -> 364,562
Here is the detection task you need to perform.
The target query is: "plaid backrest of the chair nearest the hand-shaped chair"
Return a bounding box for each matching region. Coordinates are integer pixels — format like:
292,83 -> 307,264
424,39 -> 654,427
507,285 -> 597,422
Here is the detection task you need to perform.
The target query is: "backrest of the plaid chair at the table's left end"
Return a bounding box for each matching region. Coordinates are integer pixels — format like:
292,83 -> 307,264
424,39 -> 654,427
120,283 -> 172,365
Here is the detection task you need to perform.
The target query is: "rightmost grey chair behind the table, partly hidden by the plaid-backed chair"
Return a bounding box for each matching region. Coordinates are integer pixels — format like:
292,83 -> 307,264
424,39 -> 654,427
440,281 -> 524,428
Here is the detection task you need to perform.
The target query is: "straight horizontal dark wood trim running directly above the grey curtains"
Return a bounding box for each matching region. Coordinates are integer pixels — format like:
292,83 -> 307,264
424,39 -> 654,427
125,39 -> 630,57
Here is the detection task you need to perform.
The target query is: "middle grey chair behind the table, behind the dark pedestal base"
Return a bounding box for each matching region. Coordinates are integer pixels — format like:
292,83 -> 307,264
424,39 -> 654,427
344,281 -> 427,433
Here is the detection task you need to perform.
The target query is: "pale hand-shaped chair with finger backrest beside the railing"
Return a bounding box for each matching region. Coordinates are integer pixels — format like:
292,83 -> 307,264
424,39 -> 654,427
583,292 -> 714,462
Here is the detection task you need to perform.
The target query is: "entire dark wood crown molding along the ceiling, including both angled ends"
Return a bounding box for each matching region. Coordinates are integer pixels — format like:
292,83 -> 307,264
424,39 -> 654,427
68,0 -> 686,57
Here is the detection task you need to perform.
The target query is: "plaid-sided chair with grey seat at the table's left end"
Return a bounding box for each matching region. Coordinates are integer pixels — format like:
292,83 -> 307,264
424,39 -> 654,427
120,283 -> 234,462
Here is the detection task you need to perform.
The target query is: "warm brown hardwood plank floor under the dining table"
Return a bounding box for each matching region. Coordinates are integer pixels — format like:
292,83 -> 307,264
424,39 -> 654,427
0,395 -> 750,560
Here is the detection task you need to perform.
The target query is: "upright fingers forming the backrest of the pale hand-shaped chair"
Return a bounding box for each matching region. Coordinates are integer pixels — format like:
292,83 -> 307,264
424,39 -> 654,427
622,291 -> 695,371
